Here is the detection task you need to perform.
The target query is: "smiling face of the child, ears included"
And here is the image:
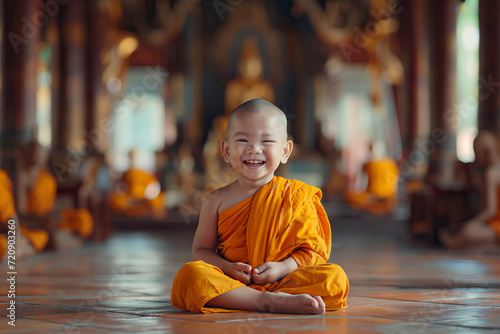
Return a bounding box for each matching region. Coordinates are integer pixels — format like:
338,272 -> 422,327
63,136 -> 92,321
221,105 -> 292,186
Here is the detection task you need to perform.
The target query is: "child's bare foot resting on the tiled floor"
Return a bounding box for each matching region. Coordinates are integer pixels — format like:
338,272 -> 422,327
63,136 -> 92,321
263,292 -> 326,314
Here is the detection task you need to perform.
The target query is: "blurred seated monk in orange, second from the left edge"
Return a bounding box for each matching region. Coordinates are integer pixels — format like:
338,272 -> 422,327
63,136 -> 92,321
19,142 -> 94,252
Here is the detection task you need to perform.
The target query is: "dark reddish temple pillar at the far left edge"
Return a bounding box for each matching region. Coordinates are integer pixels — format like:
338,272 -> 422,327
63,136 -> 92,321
0,0 -> 40,149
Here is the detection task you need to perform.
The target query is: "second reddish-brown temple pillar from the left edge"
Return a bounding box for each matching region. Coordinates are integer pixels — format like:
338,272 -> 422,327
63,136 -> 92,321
53,0 -> 86,151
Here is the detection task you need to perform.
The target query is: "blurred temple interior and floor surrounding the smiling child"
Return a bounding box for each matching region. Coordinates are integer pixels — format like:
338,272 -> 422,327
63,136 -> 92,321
0,0 -> 500,333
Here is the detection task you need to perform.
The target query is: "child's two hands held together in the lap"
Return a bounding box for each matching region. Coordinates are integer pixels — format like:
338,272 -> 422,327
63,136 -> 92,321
224,262 -> 289,285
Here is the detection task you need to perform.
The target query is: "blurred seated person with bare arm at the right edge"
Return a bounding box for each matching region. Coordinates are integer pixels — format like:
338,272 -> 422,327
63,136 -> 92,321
438,131 -> 500,249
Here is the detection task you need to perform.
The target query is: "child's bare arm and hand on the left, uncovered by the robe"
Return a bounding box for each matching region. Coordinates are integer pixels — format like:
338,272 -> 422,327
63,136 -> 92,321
192,190 -> 252,284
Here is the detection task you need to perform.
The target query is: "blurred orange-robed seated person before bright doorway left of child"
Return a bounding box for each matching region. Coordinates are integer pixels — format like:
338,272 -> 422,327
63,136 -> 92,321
109,150 -> 167,219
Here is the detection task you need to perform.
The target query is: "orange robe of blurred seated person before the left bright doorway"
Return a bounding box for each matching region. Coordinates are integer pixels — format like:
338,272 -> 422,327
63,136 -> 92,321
109,169 -> 165,217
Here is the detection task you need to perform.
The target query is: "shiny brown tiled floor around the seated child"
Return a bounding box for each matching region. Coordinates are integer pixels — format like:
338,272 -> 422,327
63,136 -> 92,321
0,215 -> 500,334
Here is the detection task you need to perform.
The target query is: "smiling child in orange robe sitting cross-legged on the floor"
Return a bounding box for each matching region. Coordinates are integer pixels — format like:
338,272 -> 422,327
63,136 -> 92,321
172,99 -> 349,314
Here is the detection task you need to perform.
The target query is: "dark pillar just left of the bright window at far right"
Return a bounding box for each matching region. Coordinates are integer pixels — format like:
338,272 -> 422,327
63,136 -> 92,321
426,0 -> 459,187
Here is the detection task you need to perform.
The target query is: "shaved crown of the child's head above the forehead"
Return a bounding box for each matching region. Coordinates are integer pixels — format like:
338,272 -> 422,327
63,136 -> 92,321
226,99 -> 288,141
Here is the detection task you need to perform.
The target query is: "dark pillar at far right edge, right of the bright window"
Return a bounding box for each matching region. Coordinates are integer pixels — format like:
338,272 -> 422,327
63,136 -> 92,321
478,0 -> 500,134
